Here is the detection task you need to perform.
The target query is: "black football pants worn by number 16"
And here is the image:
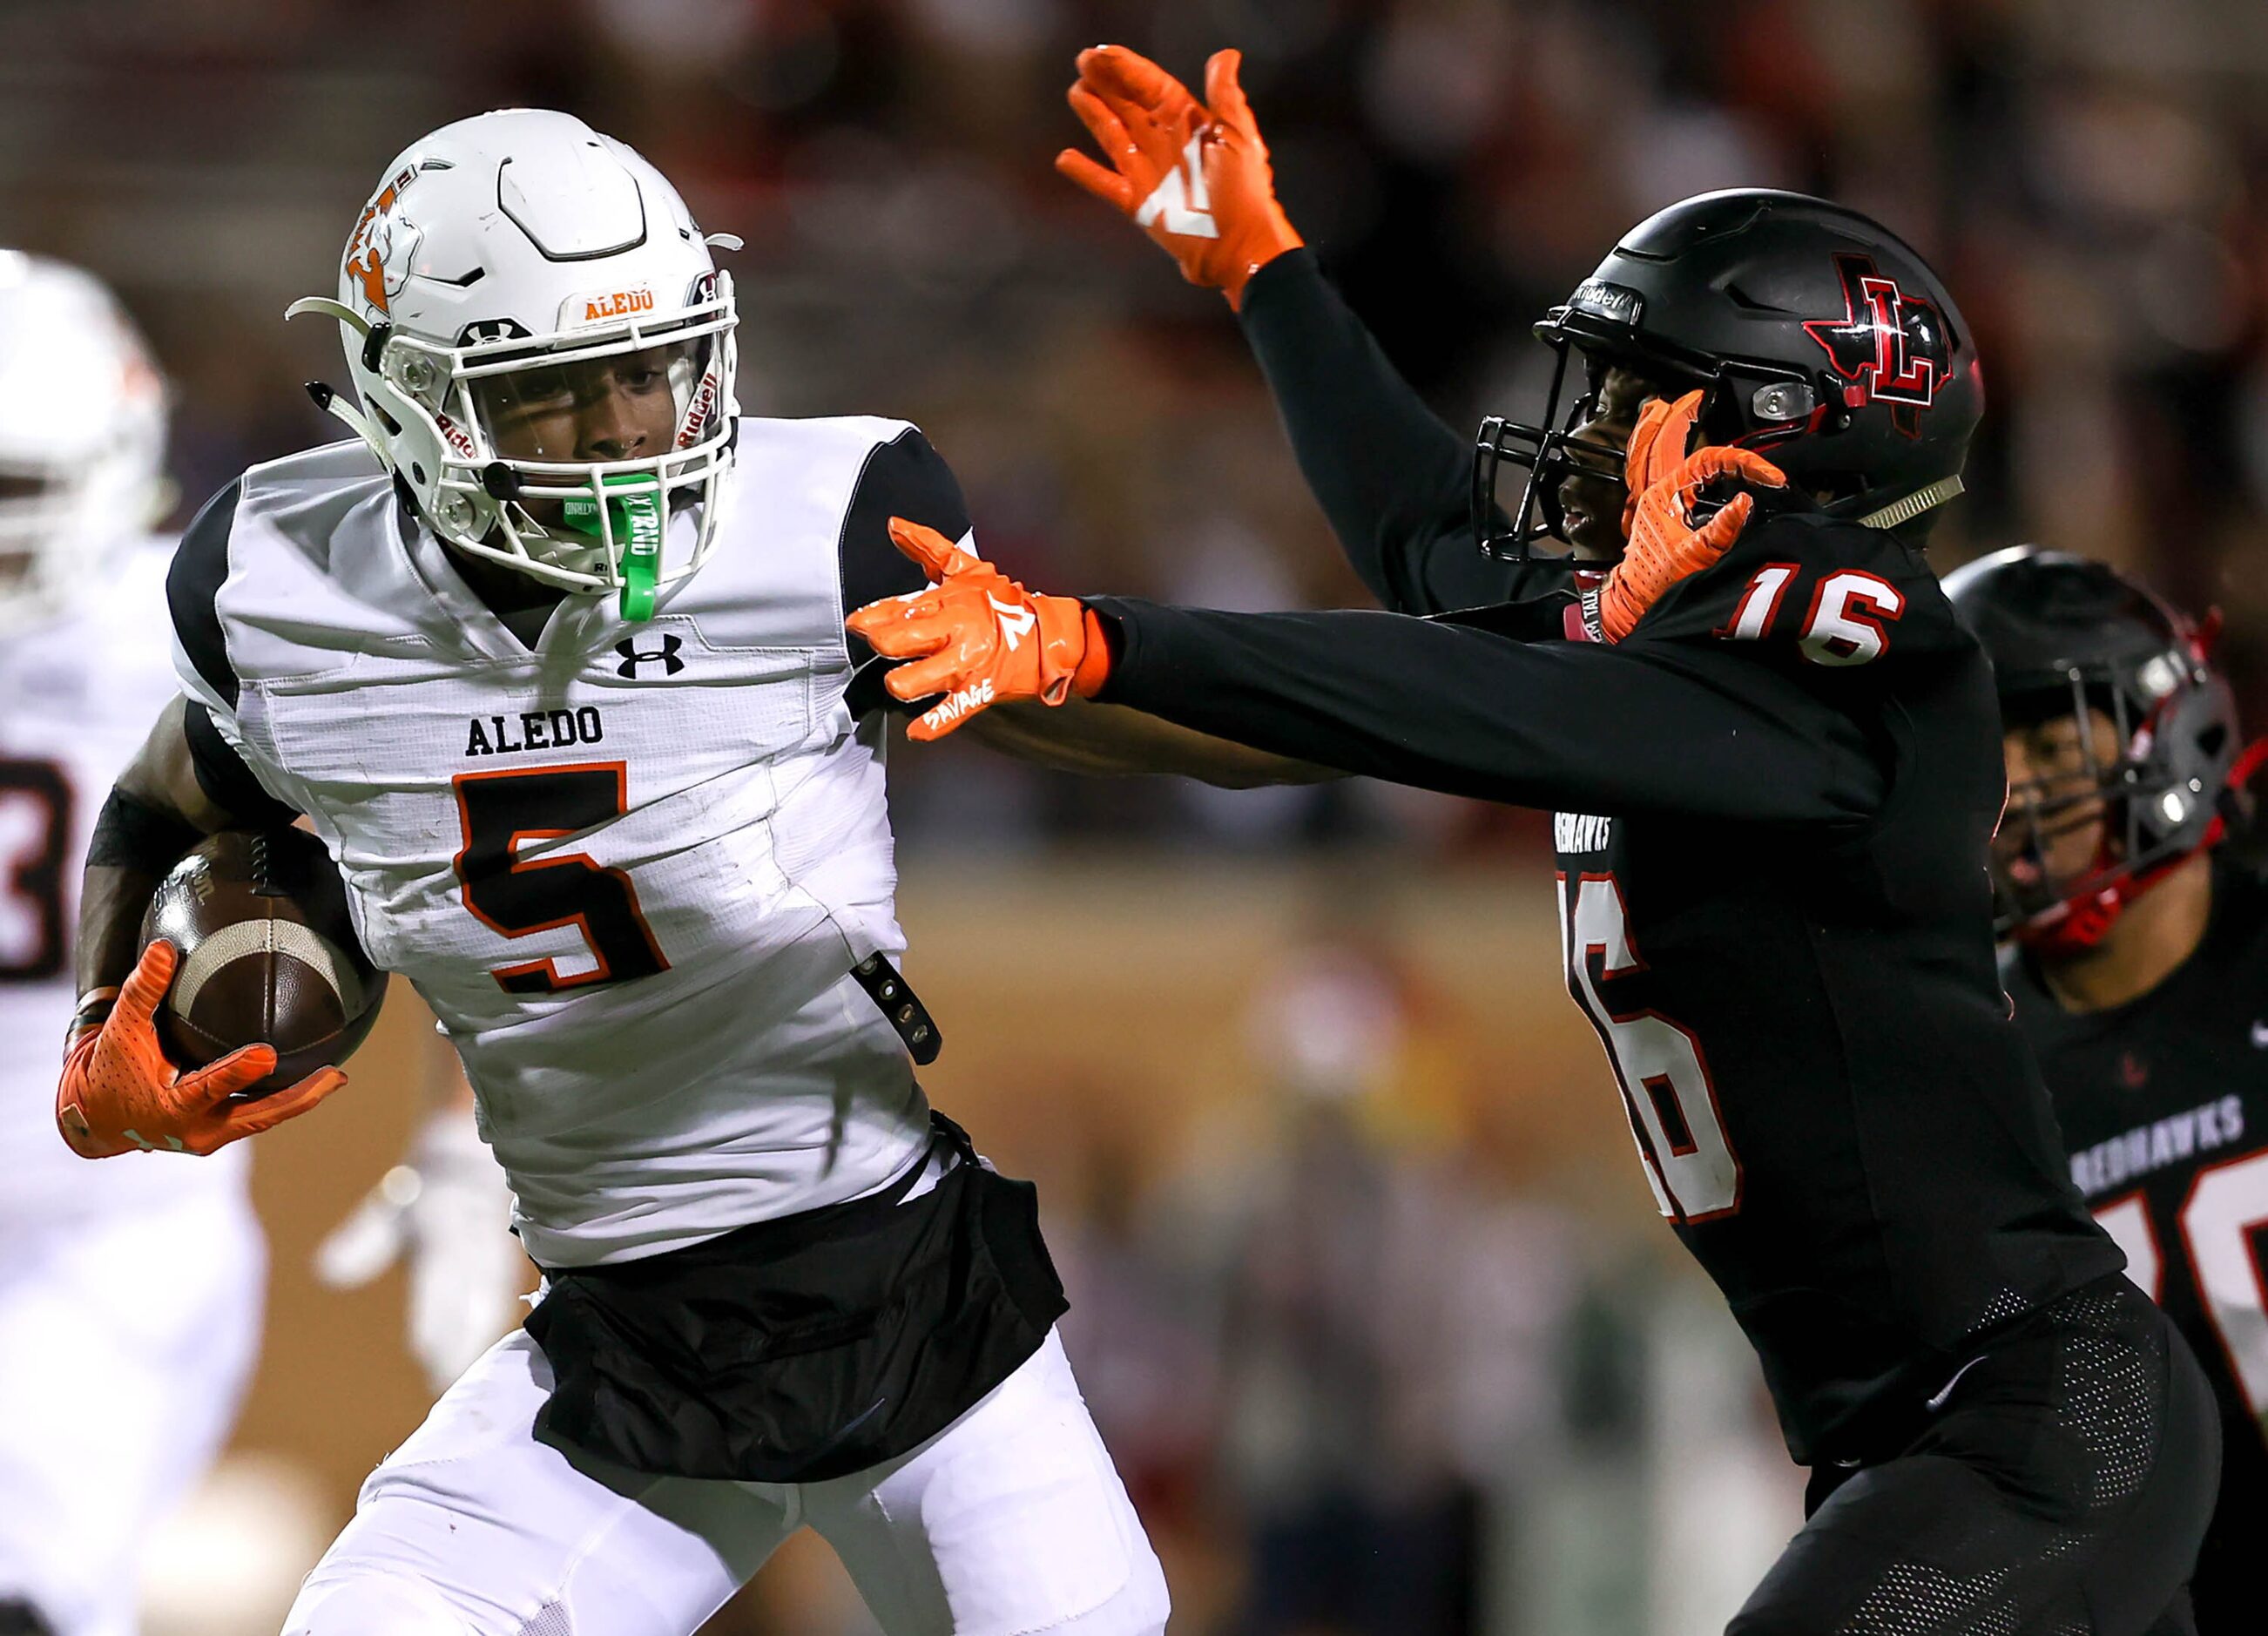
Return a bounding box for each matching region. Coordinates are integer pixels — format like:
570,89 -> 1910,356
1726,1277 -> 2220,1636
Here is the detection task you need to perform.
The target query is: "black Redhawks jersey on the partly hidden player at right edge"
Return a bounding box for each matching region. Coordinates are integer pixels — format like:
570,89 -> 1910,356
2002,848 -> 2268,1636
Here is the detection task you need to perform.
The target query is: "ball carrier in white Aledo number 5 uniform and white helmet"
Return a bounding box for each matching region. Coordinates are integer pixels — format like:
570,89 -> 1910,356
57,112 -> 1315,1636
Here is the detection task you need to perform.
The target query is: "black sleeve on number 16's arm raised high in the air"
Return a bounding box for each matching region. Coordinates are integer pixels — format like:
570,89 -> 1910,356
1239,250 -> 1565,612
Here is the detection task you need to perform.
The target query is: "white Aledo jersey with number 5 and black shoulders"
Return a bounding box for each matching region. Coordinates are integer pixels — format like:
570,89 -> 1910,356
172,420 -> 964,1266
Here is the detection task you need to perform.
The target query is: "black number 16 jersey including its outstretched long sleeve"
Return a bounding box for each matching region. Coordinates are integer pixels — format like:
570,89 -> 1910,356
1093,513 -> 2121,1461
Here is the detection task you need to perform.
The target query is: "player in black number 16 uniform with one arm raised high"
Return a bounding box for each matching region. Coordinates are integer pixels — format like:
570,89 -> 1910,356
853,50 -> 2218,1636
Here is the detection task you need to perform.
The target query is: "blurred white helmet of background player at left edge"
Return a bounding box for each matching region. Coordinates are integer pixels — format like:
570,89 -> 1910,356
0,250 -> 170,633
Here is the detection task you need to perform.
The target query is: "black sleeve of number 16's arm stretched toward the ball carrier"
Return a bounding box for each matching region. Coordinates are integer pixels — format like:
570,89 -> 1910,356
1089,597 -> 1887,824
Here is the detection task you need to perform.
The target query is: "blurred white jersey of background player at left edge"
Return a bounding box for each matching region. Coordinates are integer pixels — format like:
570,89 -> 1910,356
0,540 -> 245,1220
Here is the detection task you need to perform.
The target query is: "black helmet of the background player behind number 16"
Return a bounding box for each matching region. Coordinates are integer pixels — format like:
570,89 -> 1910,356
1944,544 -> 2241,950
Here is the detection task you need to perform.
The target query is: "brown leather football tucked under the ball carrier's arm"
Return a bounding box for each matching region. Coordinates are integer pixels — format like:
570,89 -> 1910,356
143,828 -> 386,1096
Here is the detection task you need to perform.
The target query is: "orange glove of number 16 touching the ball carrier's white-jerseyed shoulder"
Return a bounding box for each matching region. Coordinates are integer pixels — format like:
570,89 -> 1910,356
844,517 -> 1111,742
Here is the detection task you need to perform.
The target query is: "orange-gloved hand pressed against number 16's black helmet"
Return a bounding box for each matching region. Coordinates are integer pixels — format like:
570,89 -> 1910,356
1599,393 -> 1787,642
